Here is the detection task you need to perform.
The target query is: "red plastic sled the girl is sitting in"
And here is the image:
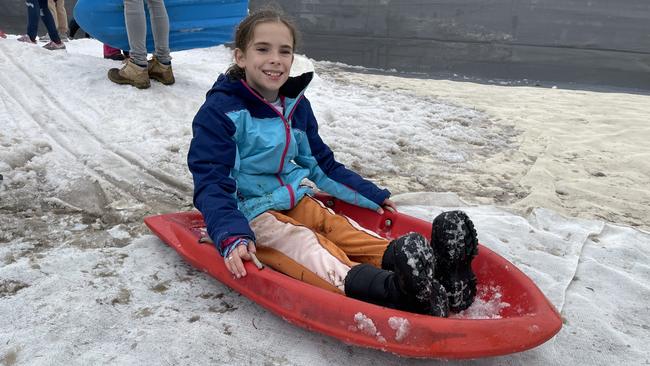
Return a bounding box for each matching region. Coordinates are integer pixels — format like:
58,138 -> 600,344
145,196 -> 562,359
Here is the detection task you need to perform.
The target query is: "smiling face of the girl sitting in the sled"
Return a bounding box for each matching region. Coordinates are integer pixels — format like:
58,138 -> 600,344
235,22 -> 293,102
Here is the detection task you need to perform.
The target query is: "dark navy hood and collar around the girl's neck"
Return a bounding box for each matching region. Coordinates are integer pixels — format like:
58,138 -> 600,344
206,72 -> 314,102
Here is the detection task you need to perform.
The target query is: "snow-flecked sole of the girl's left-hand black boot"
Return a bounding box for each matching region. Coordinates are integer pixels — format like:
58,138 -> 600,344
382,233 -> 448,317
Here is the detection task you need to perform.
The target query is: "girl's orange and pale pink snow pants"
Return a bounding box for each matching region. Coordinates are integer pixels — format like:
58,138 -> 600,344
250,196 -> 388,293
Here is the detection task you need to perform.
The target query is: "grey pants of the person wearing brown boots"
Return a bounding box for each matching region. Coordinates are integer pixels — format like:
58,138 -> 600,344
124,0 -> 172,65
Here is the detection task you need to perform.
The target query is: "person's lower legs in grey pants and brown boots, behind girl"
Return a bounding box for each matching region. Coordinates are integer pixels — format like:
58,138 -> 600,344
108,0 -> 175,89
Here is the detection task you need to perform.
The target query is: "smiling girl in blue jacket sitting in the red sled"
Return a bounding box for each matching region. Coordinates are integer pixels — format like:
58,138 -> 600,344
188,10 -> 477,316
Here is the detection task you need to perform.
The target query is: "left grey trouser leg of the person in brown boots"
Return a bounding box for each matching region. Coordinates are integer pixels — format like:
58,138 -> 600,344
124,0 -> 147,67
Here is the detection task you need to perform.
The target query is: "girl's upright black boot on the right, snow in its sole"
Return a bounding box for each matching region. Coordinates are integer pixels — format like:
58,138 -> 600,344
431,211 -> 478,312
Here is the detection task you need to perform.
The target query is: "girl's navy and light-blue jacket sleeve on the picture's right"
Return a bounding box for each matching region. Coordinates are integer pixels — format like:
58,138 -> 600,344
296,98 -> 390,209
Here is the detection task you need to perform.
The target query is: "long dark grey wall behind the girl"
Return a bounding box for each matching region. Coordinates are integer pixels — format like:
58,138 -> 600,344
250,0 -> 650,89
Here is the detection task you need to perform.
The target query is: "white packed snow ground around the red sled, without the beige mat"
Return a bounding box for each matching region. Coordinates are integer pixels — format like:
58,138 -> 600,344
0,36 -> 650,365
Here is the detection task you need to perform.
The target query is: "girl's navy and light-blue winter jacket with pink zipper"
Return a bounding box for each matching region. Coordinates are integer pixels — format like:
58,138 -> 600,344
187,73 -> 390,254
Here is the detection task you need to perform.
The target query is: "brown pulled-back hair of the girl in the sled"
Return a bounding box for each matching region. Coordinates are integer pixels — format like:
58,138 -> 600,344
226,8 -> 300,79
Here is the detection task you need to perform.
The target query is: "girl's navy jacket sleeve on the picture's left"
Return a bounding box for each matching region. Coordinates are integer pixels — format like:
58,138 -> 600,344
187,101 -> 255,255
